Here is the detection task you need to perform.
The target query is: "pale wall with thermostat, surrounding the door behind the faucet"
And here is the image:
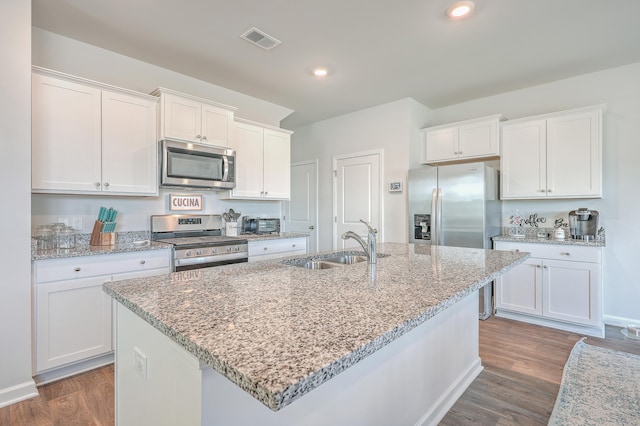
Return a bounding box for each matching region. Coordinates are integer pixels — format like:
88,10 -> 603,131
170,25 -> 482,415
291,98 -> 429,250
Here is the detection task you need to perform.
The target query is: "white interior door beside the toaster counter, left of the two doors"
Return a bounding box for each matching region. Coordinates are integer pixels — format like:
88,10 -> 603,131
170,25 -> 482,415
284,160 -> 318,253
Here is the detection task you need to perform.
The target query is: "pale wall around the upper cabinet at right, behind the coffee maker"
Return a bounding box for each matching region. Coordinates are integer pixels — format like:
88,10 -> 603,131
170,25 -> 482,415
420,63 -> 640,325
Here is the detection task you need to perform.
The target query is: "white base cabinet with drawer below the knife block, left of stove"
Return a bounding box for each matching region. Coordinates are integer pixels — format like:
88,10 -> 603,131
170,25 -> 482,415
33,250 -> 171,374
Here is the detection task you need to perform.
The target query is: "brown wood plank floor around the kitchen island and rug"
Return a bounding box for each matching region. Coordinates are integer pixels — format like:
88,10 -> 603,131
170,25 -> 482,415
0,317 -> 640,426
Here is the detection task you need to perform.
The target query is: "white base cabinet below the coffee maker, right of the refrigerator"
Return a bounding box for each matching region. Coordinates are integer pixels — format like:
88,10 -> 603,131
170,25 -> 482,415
495,242 -> 604,337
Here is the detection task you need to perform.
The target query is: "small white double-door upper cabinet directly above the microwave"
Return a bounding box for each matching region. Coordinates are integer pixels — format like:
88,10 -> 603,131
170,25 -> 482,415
152,88 -> 236,147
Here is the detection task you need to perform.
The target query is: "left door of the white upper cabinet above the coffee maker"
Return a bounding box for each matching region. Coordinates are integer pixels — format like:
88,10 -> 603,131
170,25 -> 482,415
500,120 -> 547,200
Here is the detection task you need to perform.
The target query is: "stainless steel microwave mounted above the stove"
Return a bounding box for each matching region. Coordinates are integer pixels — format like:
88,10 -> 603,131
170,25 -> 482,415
160,139 -> 236,189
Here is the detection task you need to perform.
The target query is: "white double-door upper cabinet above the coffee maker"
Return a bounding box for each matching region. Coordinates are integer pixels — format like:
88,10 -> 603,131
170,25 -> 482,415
500,106 -> 603,200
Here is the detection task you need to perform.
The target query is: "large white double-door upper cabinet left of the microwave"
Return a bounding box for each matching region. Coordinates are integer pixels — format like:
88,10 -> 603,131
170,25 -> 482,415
31,67 -> 158,195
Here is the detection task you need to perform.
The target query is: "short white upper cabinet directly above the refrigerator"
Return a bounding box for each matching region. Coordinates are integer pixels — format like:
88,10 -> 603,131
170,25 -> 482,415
421,114 -> 504,164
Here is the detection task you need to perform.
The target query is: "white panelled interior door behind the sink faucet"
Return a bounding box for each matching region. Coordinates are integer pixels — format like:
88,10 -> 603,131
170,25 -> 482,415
333,151 -> 383,249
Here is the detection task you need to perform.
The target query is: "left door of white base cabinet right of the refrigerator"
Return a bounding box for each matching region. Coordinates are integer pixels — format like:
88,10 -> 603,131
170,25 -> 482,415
496,259 -> 542,315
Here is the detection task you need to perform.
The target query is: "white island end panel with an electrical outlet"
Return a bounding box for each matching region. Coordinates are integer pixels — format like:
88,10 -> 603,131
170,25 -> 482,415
114,303 -> 202,426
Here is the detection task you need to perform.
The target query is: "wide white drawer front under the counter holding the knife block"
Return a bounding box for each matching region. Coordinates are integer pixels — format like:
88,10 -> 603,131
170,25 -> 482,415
34,250 -> 171,283
